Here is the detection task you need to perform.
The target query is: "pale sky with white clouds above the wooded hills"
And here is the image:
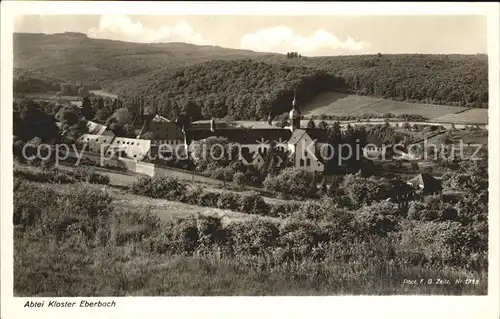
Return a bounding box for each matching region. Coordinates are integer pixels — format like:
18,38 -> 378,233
14,15 -> 487,56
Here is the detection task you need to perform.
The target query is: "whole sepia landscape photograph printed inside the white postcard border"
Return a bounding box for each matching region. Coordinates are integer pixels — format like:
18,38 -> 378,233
2,2 -> 498,319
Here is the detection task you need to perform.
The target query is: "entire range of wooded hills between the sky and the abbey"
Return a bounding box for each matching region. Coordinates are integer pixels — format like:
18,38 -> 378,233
14,34 -> 488,119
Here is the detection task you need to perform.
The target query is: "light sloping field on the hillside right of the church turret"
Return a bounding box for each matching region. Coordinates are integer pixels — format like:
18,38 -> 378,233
300,92 -> 467,120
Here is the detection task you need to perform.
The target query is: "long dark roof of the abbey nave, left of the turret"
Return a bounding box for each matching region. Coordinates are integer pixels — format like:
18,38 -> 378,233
186,128 -> 291,144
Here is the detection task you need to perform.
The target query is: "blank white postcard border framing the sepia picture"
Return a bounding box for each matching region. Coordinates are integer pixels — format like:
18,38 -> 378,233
0,1 -> 500,319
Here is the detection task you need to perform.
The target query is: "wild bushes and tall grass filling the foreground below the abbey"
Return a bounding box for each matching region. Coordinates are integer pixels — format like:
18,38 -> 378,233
14,164 -> 487,296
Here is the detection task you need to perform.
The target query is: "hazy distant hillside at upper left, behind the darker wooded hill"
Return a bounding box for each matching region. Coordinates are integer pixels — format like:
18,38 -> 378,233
14,33 -> 274,82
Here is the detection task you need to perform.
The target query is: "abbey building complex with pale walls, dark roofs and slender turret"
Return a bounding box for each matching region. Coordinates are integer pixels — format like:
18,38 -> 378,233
79,96 -> 328,173
